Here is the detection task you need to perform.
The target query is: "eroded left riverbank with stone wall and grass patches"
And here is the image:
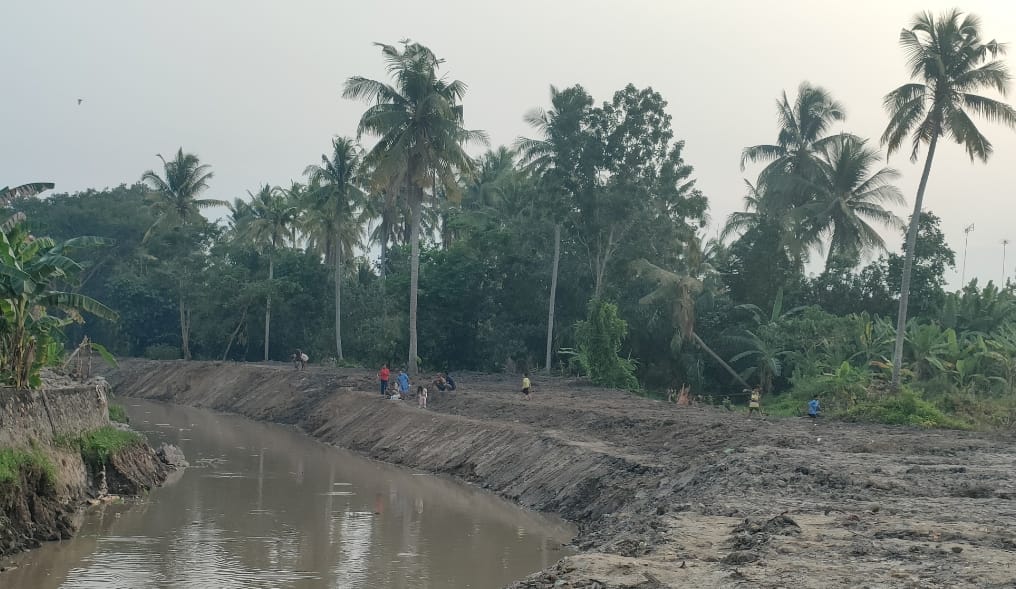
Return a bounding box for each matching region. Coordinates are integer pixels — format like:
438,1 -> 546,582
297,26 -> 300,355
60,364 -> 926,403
0,379 -> 170,560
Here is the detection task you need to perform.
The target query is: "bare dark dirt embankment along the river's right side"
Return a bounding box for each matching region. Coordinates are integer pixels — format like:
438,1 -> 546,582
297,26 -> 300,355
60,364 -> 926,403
110,361 -> 1016,589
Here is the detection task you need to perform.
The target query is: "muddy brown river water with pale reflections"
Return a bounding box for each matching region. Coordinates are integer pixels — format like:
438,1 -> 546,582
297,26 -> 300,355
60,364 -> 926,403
0,399 -> 574,589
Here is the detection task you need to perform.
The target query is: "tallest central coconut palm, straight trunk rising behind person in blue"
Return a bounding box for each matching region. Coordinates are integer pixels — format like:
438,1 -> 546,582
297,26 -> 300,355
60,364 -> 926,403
342,41 -> 487,374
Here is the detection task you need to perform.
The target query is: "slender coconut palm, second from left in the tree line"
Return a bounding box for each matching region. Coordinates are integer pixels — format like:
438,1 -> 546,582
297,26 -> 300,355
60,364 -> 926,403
243,184 -> 299,362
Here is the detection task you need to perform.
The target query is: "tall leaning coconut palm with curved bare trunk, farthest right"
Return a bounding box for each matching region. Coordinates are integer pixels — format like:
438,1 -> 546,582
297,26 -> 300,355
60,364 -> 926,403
882,10 -> 1016,389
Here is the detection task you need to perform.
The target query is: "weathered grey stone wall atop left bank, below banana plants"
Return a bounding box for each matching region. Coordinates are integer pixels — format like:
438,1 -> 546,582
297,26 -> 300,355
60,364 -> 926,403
0,381 -> 110,448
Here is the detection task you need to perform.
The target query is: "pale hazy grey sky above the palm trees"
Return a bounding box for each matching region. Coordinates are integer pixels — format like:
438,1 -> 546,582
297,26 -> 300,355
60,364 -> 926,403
0,0 -> 1016,286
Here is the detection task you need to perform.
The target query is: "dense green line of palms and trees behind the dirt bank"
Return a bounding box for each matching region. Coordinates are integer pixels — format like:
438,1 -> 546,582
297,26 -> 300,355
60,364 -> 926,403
5,11 -> 1016,422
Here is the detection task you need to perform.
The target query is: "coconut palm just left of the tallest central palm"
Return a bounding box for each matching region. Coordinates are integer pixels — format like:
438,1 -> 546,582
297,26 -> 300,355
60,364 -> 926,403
303,137 -> 367,359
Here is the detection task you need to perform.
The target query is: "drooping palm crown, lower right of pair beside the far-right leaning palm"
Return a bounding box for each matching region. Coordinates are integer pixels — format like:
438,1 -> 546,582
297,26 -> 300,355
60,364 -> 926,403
799,134 -> 905,269
